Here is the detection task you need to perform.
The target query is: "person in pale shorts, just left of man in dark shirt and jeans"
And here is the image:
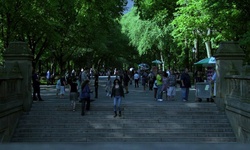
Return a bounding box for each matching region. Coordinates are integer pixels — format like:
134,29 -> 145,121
167,69 -> 177,100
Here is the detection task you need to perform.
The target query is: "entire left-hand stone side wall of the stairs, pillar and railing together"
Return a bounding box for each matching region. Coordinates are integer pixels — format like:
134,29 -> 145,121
0,42 -> 32,142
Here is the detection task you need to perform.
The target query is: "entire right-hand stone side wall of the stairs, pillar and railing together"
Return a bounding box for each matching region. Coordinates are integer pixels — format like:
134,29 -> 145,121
215,42 -> 250,143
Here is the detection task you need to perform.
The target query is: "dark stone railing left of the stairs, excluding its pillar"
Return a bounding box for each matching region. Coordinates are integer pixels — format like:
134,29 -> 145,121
0,63 -> 23,142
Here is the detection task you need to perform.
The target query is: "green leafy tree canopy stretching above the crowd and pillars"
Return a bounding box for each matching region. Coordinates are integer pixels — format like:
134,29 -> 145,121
0,0 -> 250,73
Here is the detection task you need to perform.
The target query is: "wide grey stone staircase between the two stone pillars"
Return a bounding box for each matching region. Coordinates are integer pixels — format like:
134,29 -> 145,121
11,83 -> 236,143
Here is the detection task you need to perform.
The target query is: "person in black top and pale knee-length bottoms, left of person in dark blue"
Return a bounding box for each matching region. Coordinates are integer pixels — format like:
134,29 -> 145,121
69,77 -> 78,111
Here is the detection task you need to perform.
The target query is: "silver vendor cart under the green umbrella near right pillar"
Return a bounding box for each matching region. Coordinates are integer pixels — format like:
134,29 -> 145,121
195,82 -> 213,100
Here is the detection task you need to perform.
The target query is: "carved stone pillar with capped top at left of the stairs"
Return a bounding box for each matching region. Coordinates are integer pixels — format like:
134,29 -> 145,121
3,42 -> 33,111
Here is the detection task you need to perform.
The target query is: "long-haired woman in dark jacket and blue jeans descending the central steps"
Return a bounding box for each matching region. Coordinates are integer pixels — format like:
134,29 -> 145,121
111,79 -> 124,117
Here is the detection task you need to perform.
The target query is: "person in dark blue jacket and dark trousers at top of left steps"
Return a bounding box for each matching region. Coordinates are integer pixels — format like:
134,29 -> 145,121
80,79 -> 91,116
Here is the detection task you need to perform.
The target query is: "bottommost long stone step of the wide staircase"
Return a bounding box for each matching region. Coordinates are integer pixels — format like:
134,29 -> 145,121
12,136 -> 235,143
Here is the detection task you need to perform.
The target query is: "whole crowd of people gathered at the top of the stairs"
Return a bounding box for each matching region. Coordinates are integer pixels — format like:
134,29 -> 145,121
33,68 -> 215,117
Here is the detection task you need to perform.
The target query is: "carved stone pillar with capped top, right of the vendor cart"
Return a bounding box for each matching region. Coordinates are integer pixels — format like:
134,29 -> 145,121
214,42 -> 245,111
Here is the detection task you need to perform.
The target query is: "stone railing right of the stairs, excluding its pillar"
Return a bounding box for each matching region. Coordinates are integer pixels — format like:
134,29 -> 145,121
225,66 -> 250,143
